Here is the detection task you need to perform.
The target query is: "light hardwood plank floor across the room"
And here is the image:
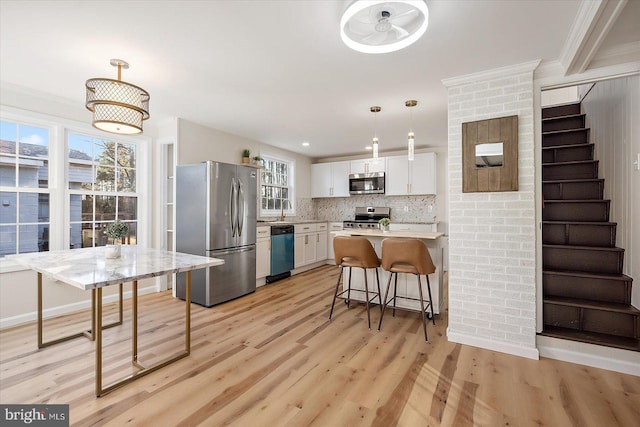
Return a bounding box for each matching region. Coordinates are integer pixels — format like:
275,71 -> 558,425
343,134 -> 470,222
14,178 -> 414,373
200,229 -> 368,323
0,266 -> 640,427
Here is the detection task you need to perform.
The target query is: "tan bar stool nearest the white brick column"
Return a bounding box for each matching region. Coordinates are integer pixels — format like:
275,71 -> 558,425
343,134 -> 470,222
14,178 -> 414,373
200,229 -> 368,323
378,237 -> 436,341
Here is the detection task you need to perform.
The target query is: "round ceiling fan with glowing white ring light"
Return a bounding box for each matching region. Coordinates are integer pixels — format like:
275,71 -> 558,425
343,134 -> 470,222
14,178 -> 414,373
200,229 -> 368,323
340,0 -> 429,53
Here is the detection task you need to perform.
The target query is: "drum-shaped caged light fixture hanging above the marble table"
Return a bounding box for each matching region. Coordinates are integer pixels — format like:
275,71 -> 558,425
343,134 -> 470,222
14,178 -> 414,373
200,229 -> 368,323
86,59 -> 149,135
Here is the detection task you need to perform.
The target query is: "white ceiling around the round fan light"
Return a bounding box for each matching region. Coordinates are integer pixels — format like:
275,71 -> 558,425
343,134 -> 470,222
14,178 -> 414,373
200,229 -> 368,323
0,0 -> 640,157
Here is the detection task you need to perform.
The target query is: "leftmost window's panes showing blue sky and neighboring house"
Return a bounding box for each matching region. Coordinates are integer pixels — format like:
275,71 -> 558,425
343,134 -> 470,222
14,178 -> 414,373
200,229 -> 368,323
0,121 -> 50,257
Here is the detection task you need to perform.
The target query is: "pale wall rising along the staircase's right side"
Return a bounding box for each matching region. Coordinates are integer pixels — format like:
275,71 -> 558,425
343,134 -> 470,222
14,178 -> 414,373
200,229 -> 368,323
582,75 -> 640,307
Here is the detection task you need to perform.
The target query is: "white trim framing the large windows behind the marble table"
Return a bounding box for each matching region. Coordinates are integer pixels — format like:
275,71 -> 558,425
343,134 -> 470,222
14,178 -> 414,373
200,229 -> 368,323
0,105 -> 152,273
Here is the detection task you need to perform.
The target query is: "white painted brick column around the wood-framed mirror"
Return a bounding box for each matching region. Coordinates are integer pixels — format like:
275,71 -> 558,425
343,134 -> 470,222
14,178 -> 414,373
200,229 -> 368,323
445,61 -> 536,348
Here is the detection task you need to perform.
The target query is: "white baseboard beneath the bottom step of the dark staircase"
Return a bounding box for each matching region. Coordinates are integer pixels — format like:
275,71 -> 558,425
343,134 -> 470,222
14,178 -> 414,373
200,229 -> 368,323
536,335 -> 640,376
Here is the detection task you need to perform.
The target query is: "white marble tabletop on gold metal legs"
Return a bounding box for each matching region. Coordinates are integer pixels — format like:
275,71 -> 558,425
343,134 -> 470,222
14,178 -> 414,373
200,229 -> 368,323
7,245 -> 224,290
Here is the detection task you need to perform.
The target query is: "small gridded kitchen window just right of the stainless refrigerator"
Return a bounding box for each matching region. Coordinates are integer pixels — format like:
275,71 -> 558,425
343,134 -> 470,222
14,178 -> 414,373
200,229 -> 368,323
260,154 -> 295,216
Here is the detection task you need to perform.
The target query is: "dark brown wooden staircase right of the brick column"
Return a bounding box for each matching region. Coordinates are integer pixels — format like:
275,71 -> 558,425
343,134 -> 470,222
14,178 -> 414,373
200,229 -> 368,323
542,103 -> 640,351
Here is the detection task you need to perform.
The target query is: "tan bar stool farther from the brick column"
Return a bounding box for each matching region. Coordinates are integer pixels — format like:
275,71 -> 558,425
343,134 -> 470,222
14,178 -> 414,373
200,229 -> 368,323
329,236 -> 382,329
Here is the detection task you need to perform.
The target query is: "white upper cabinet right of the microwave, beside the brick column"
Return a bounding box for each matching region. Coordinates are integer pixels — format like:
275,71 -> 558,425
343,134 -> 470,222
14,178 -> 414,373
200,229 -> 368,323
385,153 -> 436,196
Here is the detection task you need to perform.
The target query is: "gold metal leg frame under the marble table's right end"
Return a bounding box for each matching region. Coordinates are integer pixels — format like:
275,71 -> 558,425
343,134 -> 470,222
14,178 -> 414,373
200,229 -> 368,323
95,271 -> 191,397
